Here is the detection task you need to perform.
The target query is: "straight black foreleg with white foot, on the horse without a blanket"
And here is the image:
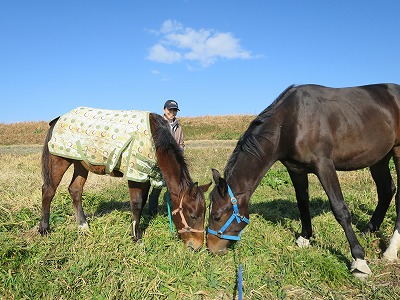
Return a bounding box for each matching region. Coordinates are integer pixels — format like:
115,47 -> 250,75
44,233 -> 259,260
288,171 -> 312,248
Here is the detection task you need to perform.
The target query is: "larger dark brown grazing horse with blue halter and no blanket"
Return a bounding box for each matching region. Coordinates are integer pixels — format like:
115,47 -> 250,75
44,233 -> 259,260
207,84 -> 400,278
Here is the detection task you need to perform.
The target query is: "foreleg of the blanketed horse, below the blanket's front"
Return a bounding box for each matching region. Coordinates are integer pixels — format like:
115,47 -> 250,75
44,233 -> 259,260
128,180 -> 150,242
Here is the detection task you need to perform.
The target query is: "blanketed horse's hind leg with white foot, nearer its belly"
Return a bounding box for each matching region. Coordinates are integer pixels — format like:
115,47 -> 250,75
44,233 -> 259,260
68,162 -> 89,230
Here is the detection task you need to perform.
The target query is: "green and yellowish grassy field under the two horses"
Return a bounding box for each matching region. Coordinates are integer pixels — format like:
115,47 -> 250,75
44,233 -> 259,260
0,116 -> 400,299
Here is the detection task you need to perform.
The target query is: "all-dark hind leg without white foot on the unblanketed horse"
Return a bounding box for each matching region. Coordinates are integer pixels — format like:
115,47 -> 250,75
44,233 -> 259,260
364,157 -> 396,232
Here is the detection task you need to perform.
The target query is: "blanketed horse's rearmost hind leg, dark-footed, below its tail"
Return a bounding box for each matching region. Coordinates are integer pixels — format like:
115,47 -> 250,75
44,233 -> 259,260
38,154 -> 71,235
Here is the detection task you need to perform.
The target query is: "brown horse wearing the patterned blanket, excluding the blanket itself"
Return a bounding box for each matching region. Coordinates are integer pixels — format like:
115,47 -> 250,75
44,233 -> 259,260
39,109 -> 211,249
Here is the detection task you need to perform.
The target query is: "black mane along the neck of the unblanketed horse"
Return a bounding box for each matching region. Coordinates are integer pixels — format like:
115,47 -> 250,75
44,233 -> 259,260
225,84 -> 296,178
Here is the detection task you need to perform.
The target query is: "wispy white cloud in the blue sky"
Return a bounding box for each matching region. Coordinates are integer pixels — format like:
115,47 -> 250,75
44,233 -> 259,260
147,20 -> 253,67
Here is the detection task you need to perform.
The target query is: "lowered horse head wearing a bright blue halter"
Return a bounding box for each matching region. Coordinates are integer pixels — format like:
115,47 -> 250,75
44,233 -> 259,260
207,169 -> 249,255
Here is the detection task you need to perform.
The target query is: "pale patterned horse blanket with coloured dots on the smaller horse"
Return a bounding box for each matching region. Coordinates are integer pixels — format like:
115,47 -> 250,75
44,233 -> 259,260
48,107 -> 163,187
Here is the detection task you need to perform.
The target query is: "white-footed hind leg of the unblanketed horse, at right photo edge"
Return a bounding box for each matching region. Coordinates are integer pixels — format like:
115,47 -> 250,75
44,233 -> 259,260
383,147 -> 400,260
